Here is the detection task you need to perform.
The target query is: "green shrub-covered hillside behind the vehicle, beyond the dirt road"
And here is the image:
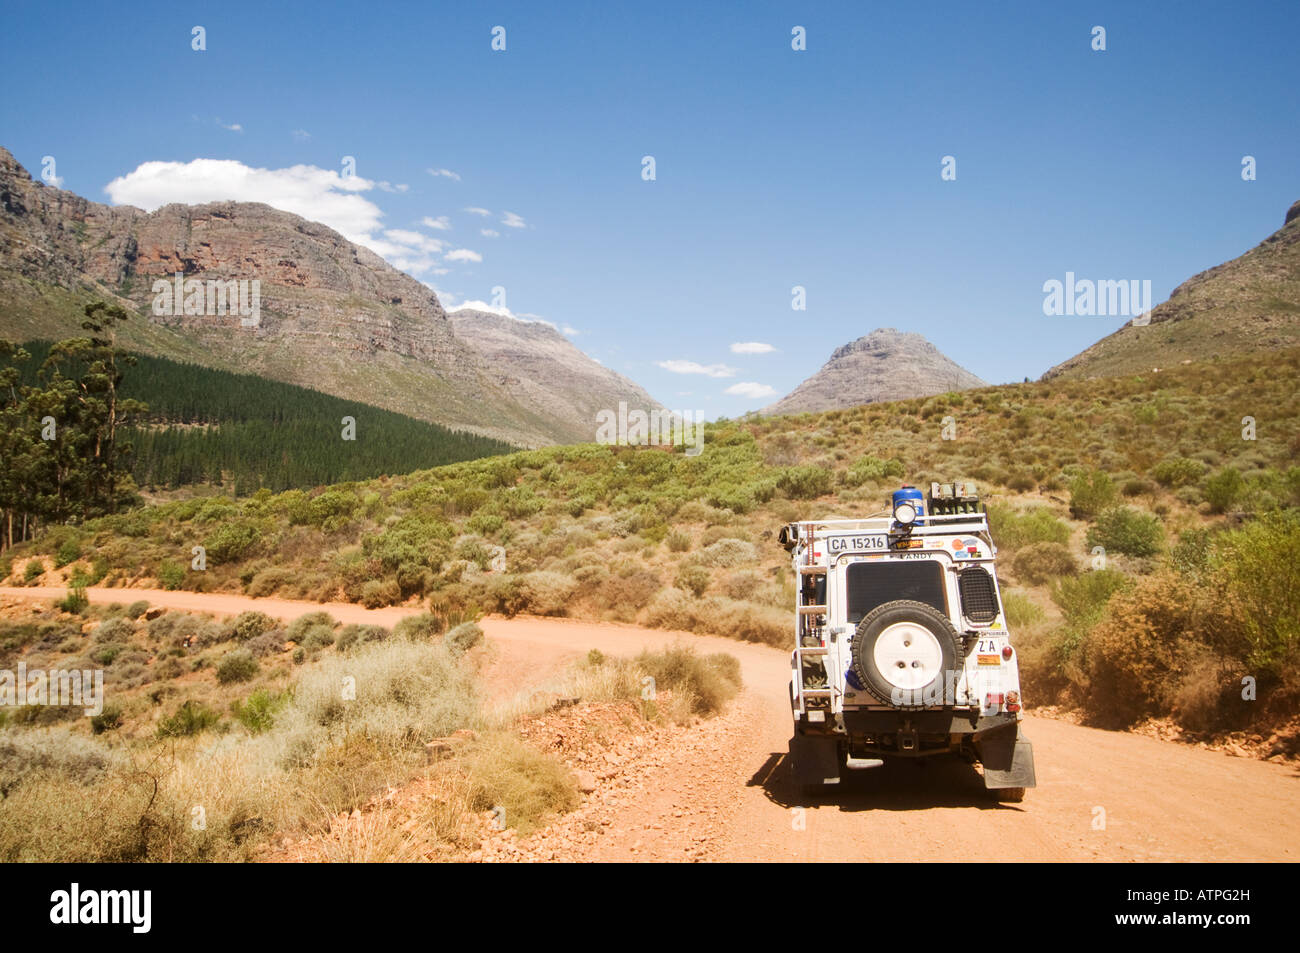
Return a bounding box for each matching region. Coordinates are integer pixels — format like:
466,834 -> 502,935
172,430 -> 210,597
10,351 -> 1300,733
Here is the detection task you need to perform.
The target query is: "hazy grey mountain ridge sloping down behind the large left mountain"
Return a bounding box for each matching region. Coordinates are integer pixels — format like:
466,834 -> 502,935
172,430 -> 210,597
450,308 -> 659,441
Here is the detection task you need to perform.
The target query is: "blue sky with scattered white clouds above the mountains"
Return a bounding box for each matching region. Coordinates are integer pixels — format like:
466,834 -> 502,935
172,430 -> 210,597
0,1 -> 1300,416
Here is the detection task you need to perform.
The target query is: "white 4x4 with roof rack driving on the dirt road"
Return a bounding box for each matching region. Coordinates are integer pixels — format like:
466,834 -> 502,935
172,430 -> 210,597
780,484 -> 1035,801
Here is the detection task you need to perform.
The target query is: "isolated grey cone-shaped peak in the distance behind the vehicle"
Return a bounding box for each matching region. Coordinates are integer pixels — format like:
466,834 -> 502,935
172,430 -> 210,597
763,328 -> 984,413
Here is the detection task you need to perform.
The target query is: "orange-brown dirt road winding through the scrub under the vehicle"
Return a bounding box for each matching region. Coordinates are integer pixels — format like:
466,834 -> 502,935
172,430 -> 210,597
0,588 -> 1300,862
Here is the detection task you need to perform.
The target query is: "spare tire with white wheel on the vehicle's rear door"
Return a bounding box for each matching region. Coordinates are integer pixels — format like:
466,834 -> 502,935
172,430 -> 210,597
852,599 -> 963,709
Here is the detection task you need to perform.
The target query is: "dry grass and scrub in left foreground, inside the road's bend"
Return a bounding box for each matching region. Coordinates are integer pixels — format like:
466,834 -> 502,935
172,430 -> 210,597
0,603 -> 740,862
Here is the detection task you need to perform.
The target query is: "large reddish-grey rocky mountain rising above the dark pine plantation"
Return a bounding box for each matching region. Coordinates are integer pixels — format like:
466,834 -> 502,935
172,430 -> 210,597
0,148 -> 634,446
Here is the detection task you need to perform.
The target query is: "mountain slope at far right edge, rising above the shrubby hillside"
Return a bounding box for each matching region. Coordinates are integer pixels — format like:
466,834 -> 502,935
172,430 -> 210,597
1043,202 -> 1300,380
